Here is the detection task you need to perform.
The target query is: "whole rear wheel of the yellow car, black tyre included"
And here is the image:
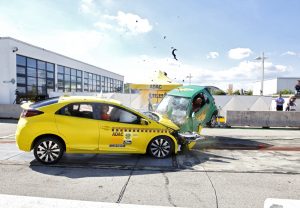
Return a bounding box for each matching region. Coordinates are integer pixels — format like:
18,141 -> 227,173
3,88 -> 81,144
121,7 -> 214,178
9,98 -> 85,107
34,137 -> 64,164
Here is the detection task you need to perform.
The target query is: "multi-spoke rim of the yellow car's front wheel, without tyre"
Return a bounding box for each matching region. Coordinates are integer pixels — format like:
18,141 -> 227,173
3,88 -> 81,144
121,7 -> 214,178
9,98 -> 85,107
150,138 -> 171,158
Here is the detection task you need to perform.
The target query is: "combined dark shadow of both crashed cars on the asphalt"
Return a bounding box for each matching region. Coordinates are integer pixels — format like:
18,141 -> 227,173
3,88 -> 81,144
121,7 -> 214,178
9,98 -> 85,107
30,137 -> 272,178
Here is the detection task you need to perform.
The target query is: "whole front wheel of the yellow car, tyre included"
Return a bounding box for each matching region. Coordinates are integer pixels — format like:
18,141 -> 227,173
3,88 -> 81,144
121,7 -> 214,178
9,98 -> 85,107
148,137 -> 173,158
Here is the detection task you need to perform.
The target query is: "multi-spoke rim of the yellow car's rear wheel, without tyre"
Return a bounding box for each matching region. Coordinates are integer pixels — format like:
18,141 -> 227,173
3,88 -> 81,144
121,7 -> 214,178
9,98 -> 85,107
36,141 -> 61,163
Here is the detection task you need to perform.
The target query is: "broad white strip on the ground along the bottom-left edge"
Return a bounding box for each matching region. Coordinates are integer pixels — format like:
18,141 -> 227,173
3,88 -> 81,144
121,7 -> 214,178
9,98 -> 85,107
0,194 -> 182,208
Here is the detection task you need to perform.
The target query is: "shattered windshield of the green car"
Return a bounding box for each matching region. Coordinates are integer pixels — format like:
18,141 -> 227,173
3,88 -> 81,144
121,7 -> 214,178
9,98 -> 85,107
156,95 -> 190,125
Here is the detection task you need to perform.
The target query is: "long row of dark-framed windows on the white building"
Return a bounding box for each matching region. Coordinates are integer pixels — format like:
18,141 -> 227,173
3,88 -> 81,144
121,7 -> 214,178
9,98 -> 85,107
16,55 -> 123,95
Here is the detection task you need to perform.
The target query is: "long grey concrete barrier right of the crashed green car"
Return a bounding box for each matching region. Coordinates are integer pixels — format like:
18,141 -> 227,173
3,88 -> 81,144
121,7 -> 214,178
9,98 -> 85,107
226,111 -> 300,127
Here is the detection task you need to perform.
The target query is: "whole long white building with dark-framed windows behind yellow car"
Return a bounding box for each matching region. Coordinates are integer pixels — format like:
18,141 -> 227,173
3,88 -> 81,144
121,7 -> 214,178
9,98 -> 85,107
0,37 -> 124,104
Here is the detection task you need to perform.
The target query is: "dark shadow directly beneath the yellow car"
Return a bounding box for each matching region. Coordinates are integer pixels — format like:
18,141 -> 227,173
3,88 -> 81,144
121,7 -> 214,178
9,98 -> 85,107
29,150 -> 218,178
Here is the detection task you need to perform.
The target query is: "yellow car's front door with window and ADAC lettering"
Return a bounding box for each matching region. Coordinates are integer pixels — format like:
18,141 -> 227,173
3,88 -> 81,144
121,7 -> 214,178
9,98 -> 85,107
99,104 -> 151,153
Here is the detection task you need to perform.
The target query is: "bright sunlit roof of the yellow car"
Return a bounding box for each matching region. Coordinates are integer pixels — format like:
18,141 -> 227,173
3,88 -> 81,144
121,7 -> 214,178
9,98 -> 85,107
58,96 -> 122,105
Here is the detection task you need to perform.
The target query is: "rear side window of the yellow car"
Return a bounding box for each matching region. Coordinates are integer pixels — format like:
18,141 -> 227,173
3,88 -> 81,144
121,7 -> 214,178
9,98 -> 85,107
58,103 -> 94,118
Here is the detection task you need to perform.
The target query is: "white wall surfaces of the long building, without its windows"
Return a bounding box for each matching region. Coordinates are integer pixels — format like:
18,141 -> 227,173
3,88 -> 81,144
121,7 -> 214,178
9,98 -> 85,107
0,38 -> 124,104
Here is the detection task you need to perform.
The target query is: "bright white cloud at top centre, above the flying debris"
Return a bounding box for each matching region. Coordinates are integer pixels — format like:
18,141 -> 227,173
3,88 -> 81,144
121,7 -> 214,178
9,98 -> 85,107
103,11 -> 153,34
